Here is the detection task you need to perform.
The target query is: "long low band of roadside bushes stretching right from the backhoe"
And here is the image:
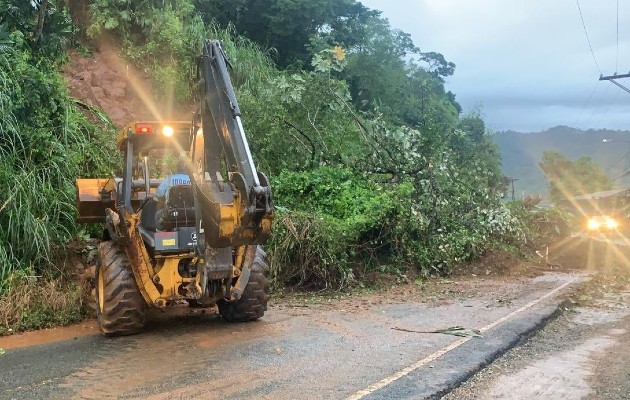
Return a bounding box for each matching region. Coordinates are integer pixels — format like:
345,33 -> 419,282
268,167 -> 525,288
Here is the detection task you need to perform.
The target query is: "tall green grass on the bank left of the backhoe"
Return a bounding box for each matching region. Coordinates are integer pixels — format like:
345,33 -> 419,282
0,43 -> 113,292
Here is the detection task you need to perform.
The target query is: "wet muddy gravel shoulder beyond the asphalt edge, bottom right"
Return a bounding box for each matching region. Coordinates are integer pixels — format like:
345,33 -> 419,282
443,285 -> 630,400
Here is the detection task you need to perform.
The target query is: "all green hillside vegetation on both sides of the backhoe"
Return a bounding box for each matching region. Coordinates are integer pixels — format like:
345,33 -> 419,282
0,0 -> 552,318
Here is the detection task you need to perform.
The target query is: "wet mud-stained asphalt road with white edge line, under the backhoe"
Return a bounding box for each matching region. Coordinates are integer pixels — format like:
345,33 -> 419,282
0,273 -> 584,399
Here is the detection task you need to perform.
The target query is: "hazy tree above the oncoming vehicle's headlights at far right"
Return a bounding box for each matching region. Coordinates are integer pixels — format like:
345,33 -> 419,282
539,151 -> 612,203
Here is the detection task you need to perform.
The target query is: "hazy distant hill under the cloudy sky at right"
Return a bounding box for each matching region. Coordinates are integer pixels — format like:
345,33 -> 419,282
493,126 -> 630,198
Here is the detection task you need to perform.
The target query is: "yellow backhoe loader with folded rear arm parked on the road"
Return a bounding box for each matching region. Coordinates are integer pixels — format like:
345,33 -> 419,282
77,40 -> 273,336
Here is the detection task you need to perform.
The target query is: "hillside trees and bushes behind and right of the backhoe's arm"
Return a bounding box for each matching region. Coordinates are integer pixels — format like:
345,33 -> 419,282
82,1 -> 519,287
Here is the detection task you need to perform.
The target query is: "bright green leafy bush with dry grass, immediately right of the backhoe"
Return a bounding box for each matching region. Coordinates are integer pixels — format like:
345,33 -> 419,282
268,167 -> 422,289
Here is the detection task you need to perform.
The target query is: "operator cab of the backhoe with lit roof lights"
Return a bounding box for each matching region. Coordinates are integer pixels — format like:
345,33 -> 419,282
117,122 -> 197,255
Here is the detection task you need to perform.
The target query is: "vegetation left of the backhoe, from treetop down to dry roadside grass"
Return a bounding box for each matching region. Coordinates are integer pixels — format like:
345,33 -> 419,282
0,0 -> 113,334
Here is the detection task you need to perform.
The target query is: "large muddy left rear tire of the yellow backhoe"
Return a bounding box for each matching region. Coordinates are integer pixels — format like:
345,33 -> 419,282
96,240 -> 147,336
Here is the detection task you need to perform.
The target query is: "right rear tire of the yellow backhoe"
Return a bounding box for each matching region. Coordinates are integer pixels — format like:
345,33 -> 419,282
217,246 -> 269,322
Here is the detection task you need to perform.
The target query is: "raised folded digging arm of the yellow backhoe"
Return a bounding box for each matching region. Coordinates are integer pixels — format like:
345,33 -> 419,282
191,40 -> 273,254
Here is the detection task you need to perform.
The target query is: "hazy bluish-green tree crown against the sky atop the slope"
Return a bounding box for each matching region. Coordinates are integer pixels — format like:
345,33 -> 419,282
342,17 -> 461,128
